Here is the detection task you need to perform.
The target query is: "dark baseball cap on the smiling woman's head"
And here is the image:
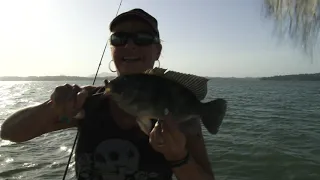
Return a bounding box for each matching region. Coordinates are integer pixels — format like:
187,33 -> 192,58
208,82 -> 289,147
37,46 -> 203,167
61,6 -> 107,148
109,8 -> 160,37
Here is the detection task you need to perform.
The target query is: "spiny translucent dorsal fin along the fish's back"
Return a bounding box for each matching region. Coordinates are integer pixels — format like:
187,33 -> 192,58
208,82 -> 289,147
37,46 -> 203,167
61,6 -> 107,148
145,68 -> 209,100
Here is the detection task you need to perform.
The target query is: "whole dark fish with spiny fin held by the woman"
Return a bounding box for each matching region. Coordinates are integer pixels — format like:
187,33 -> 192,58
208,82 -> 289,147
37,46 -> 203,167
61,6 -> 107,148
104,68 -> 227,135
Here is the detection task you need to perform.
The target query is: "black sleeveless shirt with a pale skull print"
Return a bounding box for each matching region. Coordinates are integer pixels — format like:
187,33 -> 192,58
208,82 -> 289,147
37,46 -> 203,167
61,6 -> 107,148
75,87 -> 172,180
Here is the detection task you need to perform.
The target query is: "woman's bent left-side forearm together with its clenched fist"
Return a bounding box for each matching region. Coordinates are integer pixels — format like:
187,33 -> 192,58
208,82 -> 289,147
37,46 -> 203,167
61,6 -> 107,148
0,84 -> 96,142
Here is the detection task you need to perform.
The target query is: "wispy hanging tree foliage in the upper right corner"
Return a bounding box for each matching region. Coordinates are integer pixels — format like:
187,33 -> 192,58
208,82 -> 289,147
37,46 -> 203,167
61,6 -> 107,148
263,0 -> 320,58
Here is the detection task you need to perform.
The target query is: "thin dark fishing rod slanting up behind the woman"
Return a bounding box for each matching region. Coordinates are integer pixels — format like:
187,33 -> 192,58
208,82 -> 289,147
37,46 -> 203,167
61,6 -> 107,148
62,0 -> 122,180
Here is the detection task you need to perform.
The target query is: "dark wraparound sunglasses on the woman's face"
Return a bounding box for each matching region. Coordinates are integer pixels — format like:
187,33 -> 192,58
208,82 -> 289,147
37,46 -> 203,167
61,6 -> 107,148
110,32 -> 160,46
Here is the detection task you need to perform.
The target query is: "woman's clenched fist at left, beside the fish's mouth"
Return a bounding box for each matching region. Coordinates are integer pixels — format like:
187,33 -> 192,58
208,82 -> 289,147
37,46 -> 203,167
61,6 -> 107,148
50,84 -> 88,120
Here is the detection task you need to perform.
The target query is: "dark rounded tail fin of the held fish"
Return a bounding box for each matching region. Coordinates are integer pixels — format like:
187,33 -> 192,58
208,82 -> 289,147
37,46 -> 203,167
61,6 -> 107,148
201,98 -> 227,134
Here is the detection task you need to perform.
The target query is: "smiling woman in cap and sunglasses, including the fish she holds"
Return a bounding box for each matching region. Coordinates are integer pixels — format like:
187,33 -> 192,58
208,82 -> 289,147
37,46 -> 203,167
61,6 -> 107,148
1,9 -> 226,180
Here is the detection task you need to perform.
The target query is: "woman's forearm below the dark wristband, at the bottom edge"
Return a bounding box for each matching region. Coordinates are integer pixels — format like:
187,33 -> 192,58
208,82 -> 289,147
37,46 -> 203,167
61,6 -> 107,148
172,158 -> 214,180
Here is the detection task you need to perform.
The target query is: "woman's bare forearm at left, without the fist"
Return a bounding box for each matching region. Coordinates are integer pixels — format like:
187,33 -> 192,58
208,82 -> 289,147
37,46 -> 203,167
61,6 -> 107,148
0,86 -> 101,142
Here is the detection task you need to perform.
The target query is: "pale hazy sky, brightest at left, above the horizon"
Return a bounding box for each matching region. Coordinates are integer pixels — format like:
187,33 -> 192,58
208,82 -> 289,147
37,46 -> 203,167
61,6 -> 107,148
0,0 -> 320,77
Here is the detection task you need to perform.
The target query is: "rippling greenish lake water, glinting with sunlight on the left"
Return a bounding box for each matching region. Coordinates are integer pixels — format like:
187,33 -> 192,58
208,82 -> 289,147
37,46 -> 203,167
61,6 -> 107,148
0,79 -> 320,180
